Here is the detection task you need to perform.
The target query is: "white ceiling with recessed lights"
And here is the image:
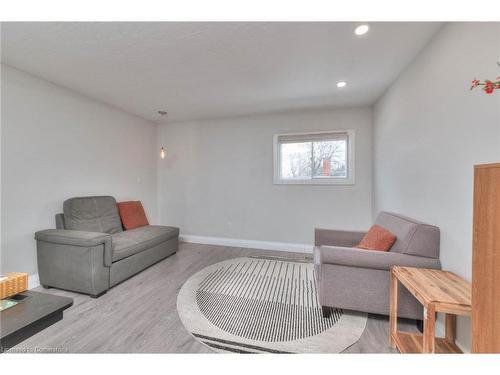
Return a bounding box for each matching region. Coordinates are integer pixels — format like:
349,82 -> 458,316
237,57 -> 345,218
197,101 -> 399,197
2,22 -> 441,122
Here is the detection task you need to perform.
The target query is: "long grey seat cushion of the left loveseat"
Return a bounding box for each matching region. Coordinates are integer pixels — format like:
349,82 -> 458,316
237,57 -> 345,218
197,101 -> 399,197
111,225 -> 179,262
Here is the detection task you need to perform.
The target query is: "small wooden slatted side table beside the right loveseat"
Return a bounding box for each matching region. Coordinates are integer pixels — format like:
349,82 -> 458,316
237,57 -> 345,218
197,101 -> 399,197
389,266 -> 471,353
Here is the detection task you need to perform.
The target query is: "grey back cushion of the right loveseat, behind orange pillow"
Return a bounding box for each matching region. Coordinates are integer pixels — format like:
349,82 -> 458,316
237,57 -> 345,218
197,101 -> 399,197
375,212 -> 440,258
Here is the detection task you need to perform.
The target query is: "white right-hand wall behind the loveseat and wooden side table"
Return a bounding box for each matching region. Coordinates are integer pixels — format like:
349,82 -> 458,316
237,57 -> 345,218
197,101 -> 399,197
373,23 -> 500,348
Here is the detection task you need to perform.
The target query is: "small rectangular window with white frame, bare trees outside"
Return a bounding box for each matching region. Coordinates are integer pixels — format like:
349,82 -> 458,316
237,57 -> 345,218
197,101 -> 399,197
274,130 -> 354,185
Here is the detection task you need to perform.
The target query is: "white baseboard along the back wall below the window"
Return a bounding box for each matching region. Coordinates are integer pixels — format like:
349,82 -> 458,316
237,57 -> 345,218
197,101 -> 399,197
179,234 -> 313,254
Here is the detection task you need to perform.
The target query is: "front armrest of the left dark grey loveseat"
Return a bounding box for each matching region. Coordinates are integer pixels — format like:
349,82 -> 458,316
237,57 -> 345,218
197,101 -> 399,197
35,229 -> 112,267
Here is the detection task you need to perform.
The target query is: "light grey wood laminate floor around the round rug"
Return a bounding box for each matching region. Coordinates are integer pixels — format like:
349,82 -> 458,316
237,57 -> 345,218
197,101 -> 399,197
6,243 -> 416,353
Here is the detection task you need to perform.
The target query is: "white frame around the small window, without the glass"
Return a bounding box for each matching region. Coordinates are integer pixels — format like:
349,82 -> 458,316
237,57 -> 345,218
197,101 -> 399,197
273,129 -> 356,185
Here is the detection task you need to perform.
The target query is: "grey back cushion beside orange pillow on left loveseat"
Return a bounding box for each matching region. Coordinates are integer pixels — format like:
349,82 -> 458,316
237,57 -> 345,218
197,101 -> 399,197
63,196 -> 123,234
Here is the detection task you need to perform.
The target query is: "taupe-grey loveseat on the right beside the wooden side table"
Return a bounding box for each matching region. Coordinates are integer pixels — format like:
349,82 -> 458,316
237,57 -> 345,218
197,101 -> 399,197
314,212 -> 441,320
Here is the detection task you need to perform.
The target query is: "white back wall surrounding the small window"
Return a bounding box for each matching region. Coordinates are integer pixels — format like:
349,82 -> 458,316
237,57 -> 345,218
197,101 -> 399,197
158,108 -> 372,250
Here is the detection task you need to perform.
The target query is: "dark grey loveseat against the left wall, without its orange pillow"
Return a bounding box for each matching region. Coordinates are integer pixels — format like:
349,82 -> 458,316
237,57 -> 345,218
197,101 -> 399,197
35,196 -> 179,298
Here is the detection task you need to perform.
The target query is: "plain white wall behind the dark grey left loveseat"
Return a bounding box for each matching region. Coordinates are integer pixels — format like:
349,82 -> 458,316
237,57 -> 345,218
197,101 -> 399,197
1,65 -> 158,280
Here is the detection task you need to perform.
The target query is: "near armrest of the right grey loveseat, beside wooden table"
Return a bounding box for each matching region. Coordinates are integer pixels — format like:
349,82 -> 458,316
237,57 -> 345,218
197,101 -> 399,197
317,246 -> 441,271
